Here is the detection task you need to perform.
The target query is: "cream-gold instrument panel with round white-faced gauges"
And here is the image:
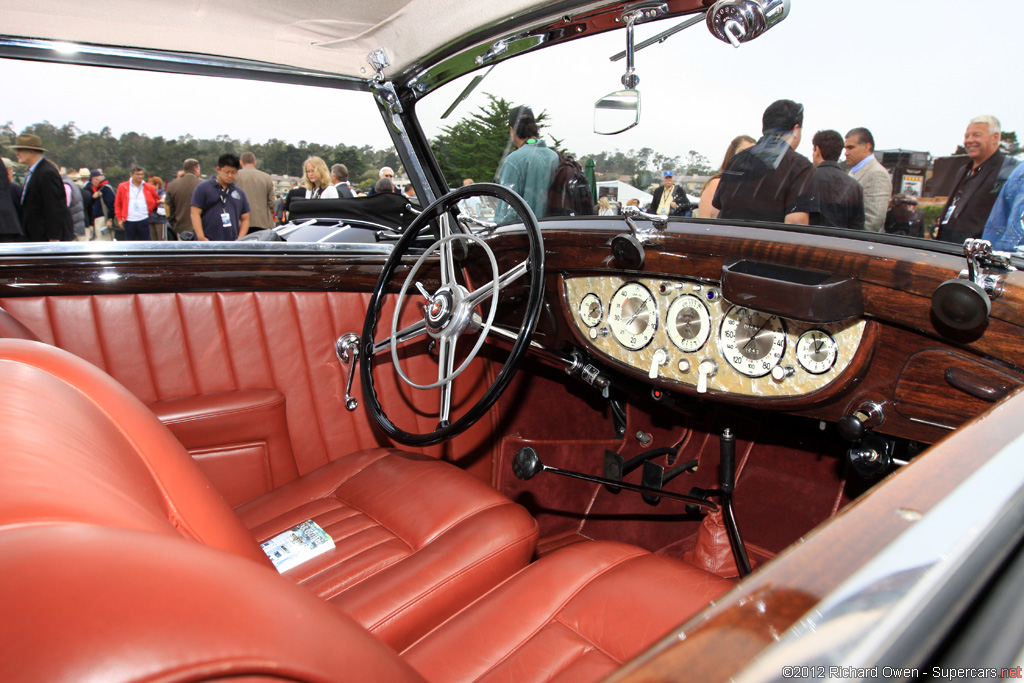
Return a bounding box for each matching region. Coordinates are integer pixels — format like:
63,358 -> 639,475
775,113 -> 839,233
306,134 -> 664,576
564,275 -> 865,397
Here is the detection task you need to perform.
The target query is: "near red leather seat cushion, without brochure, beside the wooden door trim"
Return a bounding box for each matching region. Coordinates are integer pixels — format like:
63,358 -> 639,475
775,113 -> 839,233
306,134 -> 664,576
401,541 -> 732,683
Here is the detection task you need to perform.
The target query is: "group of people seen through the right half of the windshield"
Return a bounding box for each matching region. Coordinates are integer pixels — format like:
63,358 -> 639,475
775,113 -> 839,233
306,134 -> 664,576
698,99 -> 1024,250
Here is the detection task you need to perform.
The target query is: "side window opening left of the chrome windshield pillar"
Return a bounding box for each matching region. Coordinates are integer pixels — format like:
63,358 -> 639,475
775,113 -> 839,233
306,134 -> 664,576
0,59 -> 399,242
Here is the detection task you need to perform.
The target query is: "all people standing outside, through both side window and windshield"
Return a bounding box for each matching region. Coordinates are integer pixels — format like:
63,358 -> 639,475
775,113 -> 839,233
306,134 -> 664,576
6,109 -> 1024,250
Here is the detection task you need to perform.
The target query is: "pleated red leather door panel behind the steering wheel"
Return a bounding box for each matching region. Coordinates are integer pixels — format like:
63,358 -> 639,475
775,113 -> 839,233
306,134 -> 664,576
0,292 -> 492,479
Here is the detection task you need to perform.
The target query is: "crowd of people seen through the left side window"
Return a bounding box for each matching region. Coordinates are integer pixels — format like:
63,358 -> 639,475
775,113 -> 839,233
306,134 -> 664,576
0,133 -> 407,243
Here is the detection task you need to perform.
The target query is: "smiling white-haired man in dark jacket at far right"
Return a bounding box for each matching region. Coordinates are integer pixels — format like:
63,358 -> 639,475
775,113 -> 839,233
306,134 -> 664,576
938,116 -> 1017,244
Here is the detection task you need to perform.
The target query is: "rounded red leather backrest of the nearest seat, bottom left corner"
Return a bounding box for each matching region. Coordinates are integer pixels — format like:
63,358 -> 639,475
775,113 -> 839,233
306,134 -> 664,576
0,524 -> 424,683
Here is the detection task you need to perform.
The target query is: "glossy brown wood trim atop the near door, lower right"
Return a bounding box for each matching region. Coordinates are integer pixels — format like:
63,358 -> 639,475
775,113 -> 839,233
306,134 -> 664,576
609,391 -> 1024,683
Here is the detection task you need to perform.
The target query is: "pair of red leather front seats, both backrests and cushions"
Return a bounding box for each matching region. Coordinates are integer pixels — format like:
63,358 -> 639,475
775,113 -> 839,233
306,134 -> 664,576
0,341 -> 731,683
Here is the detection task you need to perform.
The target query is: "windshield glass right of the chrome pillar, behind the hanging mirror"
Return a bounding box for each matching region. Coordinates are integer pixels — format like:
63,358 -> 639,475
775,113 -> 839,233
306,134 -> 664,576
417,0 -> 1024,249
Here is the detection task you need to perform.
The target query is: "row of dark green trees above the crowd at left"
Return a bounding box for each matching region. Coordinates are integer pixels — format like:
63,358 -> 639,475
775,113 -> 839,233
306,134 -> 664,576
0,121 -> 400,188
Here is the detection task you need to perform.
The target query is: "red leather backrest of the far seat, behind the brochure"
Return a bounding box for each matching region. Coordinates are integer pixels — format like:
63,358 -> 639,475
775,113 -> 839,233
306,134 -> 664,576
0,340 -> 268,564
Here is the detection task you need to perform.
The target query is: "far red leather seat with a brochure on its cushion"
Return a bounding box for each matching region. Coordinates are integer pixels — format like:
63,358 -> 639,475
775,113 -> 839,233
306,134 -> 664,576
0,340 -> 537,648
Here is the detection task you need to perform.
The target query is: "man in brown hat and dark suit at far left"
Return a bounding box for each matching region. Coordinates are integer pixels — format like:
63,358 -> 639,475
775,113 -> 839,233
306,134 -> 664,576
11,134 -> 75,242
